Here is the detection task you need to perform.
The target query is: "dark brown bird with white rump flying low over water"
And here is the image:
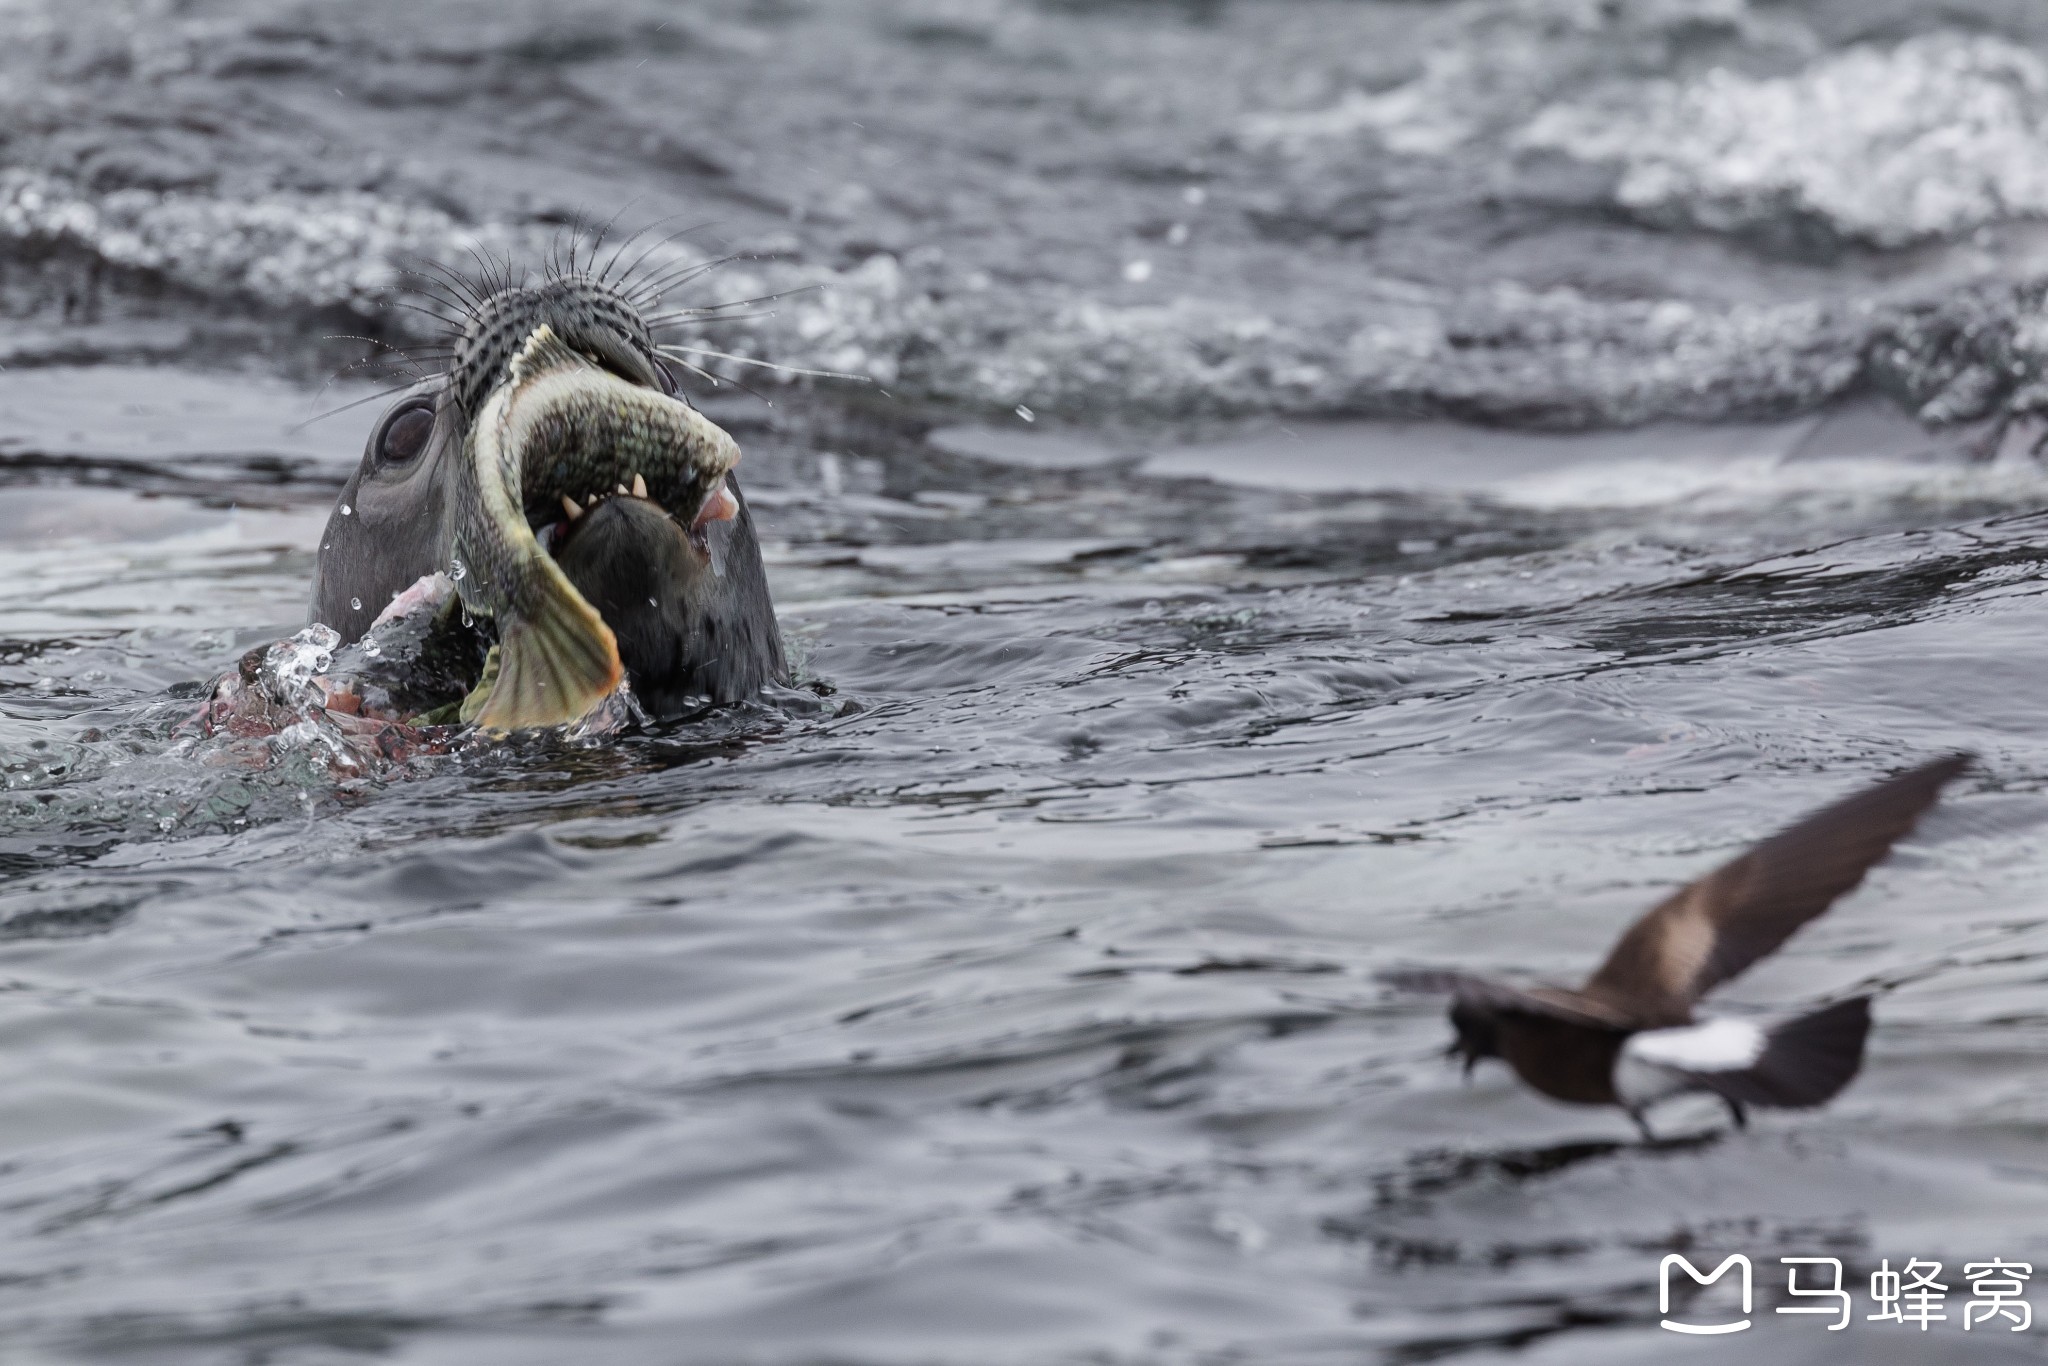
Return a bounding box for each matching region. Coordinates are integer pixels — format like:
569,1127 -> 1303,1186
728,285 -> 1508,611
1382,754 -> 1970,1141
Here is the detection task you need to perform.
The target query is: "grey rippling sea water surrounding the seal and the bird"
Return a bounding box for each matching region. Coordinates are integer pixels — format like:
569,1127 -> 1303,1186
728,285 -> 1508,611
0,0 -> 2048,1366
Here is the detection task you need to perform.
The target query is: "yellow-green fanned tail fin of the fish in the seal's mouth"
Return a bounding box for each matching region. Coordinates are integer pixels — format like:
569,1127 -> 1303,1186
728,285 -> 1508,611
465,557 -> 625,731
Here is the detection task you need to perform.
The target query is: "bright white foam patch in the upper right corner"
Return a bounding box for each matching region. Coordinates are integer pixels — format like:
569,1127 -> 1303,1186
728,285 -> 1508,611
1518,33 -> 2048,246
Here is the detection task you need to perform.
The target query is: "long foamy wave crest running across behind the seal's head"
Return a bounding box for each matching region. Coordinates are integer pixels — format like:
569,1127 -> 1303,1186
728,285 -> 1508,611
0,170 -> 2048,428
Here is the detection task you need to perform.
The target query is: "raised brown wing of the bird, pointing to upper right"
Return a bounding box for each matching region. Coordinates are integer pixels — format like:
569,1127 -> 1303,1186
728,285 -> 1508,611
1581,754 -> 1970,1028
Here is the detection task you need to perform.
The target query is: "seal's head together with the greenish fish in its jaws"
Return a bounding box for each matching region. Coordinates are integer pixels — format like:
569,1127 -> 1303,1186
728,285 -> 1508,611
311,272 -> 788,731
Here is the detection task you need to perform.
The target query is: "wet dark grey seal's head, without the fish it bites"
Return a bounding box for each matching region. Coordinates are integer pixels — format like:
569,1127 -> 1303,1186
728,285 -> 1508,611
311,260 -> 788,717
